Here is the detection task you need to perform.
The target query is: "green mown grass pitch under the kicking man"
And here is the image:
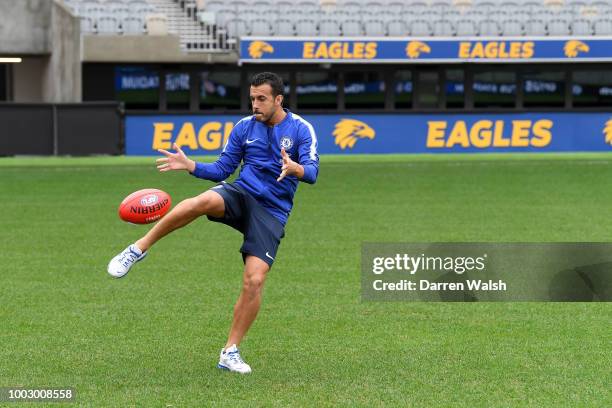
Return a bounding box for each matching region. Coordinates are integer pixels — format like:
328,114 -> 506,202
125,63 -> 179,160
0,154 -> 612,407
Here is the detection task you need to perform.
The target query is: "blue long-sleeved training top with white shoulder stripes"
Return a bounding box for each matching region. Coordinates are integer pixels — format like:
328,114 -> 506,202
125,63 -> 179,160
193,109 -> 319,225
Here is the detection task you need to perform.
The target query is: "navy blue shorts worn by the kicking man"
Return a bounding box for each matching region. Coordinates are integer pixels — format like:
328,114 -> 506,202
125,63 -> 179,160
208,183 -> 285,266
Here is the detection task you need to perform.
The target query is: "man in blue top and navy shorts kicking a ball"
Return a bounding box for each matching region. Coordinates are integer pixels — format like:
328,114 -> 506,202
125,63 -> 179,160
108,72 -> 319,374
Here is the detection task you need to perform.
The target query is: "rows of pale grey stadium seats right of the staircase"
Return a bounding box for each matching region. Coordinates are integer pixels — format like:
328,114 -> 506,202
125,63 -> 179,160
195,0 -> 612,37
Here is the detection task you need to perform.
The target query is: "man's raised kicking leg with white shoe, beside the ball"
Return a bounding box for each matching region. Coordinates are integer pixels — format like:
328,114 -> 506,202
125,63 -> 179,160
108,190 -> 225,278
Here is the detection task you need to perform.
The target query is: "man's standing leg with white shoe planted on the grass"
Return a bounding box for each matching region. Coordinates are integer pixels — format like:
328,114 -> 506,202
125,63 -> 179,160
218,255 -> 270,374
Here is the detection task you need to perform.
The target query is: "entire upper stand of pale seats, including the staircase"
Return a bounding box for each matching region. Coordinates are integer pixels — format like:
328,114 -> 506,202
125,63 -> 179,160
64,0 -> 612,52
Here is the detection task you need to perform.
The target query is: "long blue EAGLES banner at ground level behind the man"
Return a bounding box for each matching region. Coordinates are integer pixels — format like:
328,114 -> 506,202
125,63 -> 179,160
125,113 -> 612,155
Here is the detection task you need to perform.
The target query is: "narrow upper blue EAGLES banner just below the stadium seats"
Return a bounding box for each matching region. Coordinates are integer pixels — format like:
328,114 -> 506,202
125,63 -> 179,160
240,37 -> 612,63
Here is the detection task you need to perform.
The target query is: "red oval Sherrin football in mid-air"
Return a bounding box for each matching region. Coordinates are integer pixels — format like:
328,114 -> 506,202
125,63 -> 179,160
119,188 -> 172,224
